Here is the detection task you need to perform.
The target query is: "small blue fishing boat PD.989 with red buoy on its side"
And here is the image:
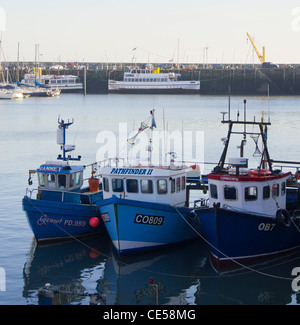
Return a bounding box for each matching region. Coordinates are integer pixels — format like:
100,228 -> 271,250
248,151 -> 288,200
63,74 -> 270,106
22,119 -> 105,242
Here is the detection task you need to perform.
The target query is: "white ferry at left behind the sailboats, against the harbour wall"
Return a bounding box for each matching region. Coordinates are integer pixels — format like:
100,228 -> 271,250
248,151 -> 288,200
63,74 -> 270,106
21,73 -> 83,92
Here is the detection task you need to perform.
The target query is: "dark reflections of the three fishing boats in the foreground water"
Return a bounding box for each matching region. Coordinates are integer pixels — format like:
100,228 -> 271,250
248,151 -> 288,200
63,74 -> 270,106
23,230 -> 300,305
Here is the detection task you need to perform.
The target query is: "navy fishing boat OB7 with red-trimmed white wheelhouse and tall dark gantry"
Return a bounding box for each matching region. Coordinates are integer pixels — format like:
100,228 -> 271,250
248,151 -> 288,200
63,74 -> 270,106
198,101 -> 300,268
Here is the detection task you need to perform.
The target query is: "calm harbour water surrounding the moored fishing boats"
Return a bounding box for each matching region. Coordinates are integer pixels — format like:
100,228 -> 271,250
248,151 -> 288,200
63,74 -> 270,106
0,94 -> 300,305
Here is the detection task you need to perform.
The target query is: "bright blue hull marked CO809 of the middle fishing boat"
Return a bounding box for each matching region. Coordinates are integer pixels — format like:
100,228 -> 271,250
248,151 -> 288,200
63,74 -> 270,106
99,197 -> 201,255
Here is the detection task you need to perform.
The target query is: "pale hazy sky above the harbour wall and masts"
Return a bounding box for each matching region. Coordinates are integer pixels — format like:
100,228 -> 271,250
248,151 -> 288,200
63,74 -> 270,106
0,0 -> 300,64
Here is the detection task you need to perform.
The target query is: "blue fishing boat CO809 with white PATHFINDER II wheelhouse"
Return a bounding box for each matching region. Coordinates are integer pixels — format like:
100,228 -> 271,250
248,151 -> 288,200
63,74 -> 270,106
99,111 -> 205,255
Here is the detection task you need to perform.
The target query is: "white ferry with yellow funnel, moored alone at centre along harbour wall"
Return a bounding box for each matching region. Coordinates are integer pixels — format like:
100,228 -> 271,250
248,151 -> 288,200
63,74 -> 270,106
108,68 -> 200,94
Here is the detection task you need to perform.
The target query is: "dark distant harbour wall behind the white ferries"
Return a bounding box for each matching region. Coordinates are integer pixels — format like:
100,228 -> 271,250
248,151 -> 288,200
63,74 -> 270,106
15,67 -> 300,96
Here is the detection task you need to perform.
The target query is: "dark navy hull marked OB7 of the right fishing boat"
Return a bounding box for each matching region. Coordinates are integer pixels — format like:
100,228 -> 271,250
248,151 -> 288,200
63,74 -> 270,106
199,208 -> 300,267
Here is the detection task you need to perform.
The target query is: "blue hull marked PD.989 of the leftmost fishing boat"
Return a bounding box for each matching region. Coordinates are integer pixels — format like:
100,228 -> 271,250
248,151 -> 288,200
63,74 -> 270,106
22,196 -> 105,242
